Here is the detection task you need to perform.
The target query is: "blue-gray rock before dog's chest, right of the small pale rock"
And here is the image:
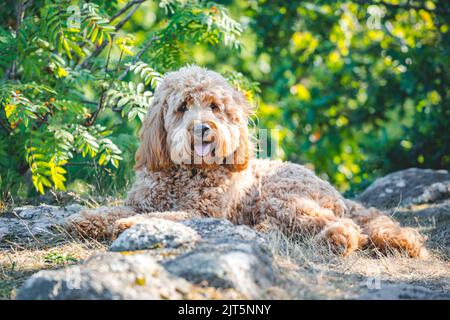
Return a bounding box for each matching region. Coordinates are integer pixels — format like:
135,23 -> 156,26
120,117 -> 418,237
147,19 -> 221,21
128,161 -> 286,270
164,219 -> 275,298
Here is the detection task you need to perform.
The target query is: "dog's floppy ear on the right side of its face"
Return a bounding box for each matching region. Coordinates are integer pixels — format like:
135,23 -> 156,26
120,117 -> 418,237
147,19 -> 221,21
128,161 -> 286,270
227,89 -> 253,171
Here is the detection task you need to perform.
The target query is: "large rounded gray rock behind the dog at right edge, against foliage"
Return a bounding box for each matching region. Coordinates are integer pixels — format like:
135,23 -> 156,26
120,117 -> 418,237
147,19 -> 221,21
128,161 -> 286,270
356,168 -> 450,209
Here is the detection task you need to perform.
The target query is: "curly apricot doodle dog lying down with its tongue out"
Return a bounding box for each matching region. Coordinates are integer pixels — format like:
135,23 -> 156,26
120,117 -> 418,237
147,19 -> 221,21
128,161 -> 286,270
68,66 -> 426,257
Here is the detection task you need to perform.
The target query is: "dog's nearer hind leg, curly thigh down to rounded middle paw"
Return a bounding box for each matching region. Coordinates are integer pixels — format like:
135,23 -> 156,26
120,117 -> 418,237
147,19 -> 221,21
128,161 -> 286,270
266,197 -> 367,255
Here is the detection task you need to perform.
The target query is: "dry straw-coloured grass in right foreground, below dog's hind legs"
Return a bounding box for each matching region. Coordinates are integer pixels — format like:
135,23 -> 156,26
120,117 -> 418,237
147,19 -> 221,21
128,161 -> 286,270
268,231 -> 450,299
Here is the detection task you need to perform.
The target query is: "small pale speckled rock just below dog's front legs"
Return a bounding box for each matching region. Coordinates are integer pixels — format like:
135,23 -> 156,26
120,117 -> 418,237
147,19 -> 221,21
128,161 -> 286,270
110,218 -> 200,251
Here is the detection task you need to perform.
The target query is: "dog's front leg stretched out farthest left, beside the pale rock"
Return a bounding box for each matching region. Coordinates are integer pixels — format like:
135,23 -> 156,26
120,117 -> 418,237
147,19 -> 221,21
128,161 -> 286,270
65,206 -> 138,239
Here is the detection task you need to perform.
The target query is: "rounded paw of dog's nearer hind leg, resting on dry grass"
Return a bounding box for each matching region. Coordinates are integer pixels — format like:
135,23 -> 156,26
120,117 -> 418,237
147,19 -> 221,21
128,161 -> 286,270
317,219 -> 368,256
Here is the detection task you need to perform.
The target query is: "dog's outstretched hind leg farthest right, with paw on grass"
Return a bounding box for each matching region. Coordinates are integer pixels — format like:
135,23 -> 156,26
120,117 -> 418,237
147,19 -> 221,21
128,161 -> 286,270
346,200 -> 428,258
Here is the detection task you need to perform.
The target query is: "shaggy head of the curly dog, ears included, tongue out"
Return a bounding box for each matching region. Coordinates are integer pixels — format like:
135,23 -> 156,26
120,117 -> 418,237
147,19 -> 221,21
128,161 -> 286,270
135,66 -> 251,171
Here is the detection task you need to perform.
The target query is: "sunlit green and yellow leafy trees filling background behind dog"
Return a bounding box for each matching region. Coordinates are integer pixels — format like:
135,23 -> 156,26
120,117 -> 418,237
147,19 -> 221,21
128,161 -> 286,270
0,0 -> 450,205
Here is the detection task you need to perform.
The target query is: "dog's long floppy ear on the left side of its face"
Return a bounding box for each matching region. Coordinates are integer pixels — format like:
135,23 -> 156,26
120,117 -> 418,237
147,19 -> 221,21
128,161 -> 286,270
134,95 -> 171,171
